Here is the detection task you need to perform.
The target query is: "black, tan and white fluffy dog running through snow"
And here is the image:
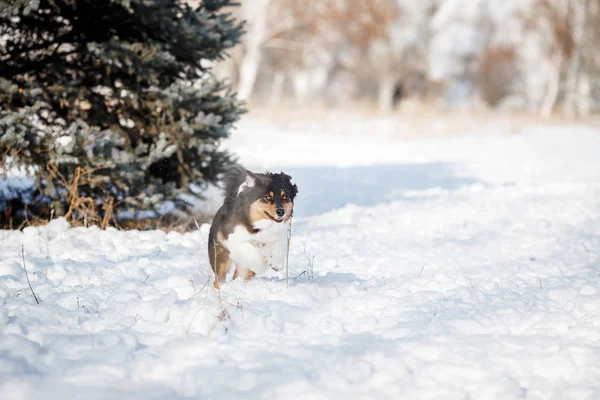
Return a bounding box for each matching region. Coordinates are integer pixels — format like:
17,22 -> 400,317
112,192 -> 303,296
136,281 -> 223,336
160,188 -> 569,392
208,165 -> 298,288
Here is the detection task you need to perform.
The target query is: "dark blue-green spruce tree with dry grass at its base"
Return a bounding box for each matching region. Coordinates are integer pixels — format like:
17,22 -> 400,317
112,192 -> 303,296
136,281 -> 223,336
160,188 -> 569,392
0,0 -> 243,225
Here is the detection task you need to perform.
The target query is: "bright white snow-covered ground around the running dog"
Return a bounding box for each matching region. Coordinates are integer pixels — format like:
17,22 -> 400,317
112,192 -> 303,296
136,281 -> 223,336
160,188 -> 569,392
0,118 -> 600,400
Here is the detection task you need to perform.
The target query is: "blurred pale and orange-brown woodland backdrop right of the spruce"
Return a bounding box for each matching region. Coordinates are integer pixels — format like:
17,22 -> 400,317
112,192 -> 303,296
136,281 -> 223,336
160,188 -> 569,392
216,0 -> 600,117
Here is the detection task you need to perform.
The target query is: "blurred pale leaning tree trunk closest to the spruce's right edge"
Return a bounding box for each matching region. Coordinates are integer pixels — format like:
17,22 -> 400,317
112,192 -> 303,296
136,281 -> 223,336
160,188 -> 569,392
237,0 -> 269,100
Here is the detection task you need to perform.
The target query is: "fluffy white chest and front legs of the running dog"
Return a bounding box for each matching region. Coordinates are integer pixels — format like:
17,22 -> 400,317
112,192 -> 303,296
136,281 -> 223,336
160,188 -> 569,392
223,220 -> 288,272
